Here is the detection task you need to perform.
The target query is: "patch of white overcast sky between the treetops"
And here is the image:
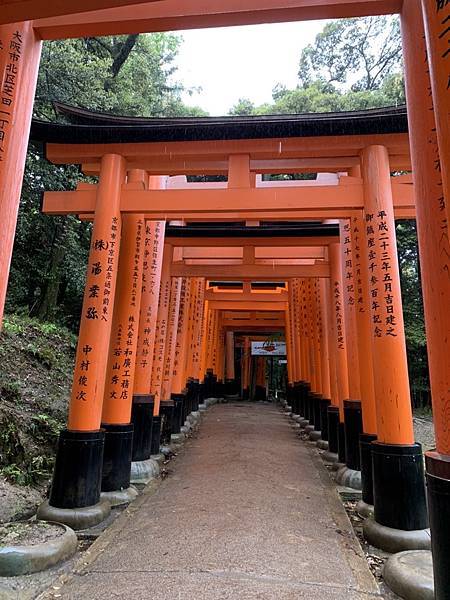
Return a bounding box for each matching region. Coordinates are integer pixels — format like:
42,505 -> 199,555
176,21 -> 325,115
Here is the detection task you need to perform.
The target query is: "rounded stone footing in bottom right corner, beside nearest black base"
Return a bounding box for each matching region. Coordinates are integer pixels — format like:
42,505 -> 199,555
383,550 -> 439,600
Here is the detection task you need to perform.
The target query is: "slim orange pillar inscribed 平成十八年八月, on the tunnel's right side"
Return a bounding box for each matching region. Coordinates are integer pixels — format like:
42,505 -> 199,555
329,244 -> 349,463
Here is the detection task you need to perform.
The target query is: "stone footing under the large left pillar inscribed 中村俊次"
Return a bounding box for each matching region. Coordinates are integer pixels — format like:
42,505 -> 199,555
36,499 -> 111,531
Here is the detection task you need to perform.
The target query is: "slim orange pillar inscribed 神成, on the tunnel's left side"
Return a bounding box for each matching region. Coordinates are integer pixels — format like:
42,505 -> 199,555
150,243 -> 173,416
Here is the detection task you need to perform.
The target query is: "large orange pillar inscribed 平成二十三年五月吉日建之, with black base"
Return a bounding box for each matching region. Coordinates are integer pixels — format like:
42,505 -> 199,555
361,145 -> 427,541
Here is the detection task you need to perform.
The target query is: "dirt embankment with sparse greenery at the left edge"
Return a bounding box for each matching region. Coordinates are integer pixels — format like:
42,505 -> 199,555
0,316 -> 76,522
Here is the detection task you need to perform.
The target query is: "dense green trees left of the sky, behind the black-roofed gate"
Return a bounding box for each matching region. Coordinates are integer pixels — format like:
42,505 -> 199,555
7,33 -> 205,328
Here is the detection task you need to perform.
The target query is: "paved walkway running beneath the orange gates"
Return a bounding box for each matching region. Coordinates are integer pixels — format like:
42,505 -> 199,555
47,403 -> 380,600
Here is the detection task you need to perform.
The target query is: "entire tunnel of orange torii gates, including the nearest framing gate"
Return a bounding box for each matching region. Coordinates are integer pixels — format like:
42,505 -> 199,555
0,0 -> 450,600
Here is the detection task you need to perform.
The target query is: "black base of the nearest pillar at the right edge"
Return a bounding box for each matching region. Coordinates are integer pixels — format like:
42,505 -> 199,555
425,451 -> 450,600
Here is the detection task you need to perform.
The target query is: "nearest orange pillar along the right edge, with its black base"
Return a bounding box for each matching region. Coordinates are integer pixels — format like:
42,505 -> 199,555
401,0 -> 450,580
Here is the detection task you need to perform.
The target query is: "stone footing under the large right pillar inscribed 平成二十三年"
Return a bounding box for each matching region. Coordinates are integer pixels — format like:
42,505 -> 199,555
363,517 -> 431,554
